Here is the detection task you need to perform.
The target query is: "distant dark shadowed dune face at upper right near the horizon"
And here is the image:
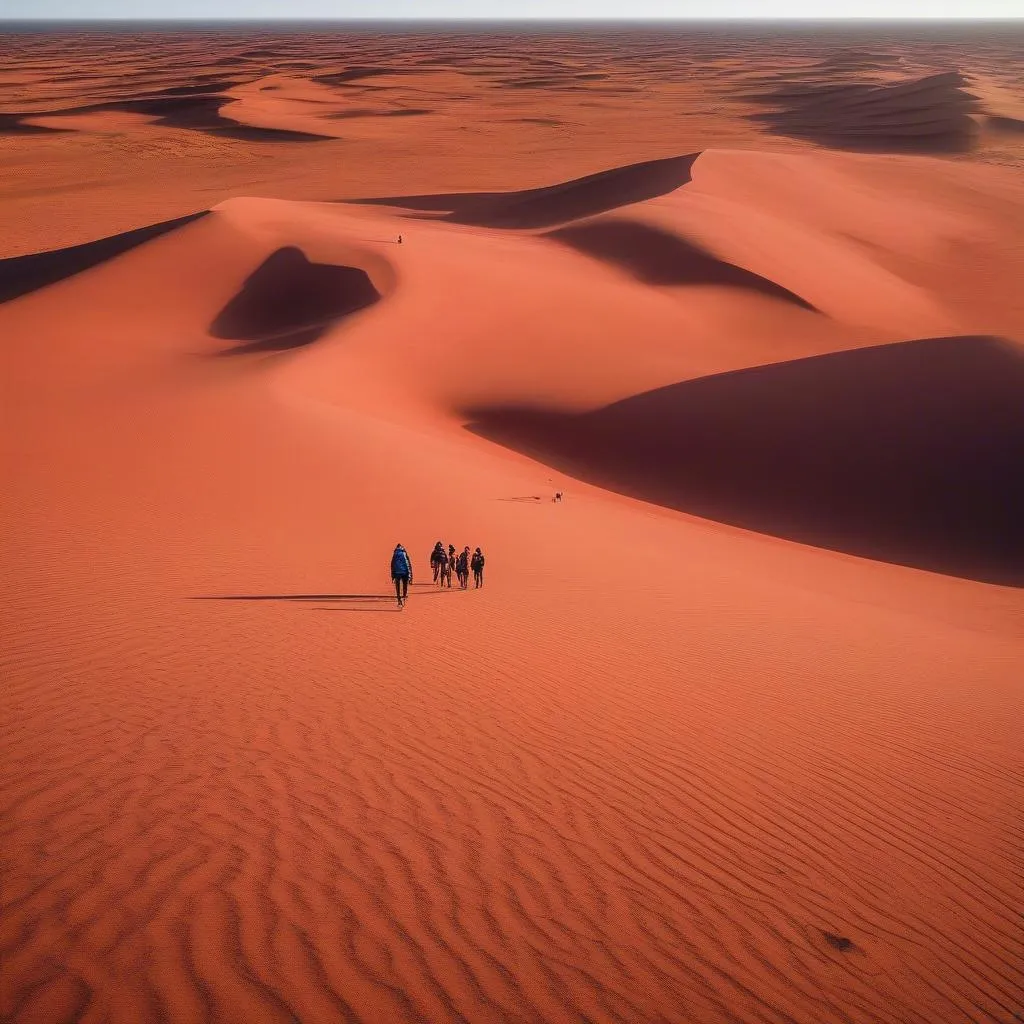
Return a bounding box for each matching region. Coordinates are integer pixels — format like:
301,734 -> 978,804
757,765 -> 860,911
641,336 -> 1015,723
750,72 -> 977,153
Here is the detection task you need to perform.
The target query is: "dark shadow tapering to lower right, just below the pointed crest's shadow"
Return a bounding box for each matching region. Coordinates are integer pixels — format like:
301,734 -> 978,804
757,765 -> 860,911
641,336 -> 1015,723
546,218 -> 816,311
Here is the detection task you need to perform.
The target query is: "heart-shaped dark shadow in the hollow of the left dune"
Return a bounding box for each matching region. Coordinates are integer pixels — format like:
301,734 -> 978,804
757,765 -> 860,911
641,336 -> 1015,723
210,246 -> 381,355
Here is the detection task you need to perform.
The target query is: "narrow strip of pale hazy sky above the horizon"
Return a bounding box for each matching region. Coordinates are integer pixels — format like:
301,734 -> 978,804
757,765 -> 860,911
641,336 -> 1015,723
8,0 -> 1024,20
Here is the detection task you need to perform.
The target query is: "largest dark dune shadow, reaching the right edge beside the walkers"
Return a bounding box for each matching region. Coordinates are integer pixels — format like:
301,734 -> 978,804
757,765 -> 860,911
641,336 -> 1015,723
467,337 -> 1024,587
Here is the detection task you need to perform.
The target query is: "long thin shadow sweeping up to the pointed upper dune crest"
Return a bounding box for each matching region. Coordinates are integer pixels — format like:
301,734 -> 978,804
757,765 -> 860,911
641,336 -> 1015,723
344,153 -> 699,229
